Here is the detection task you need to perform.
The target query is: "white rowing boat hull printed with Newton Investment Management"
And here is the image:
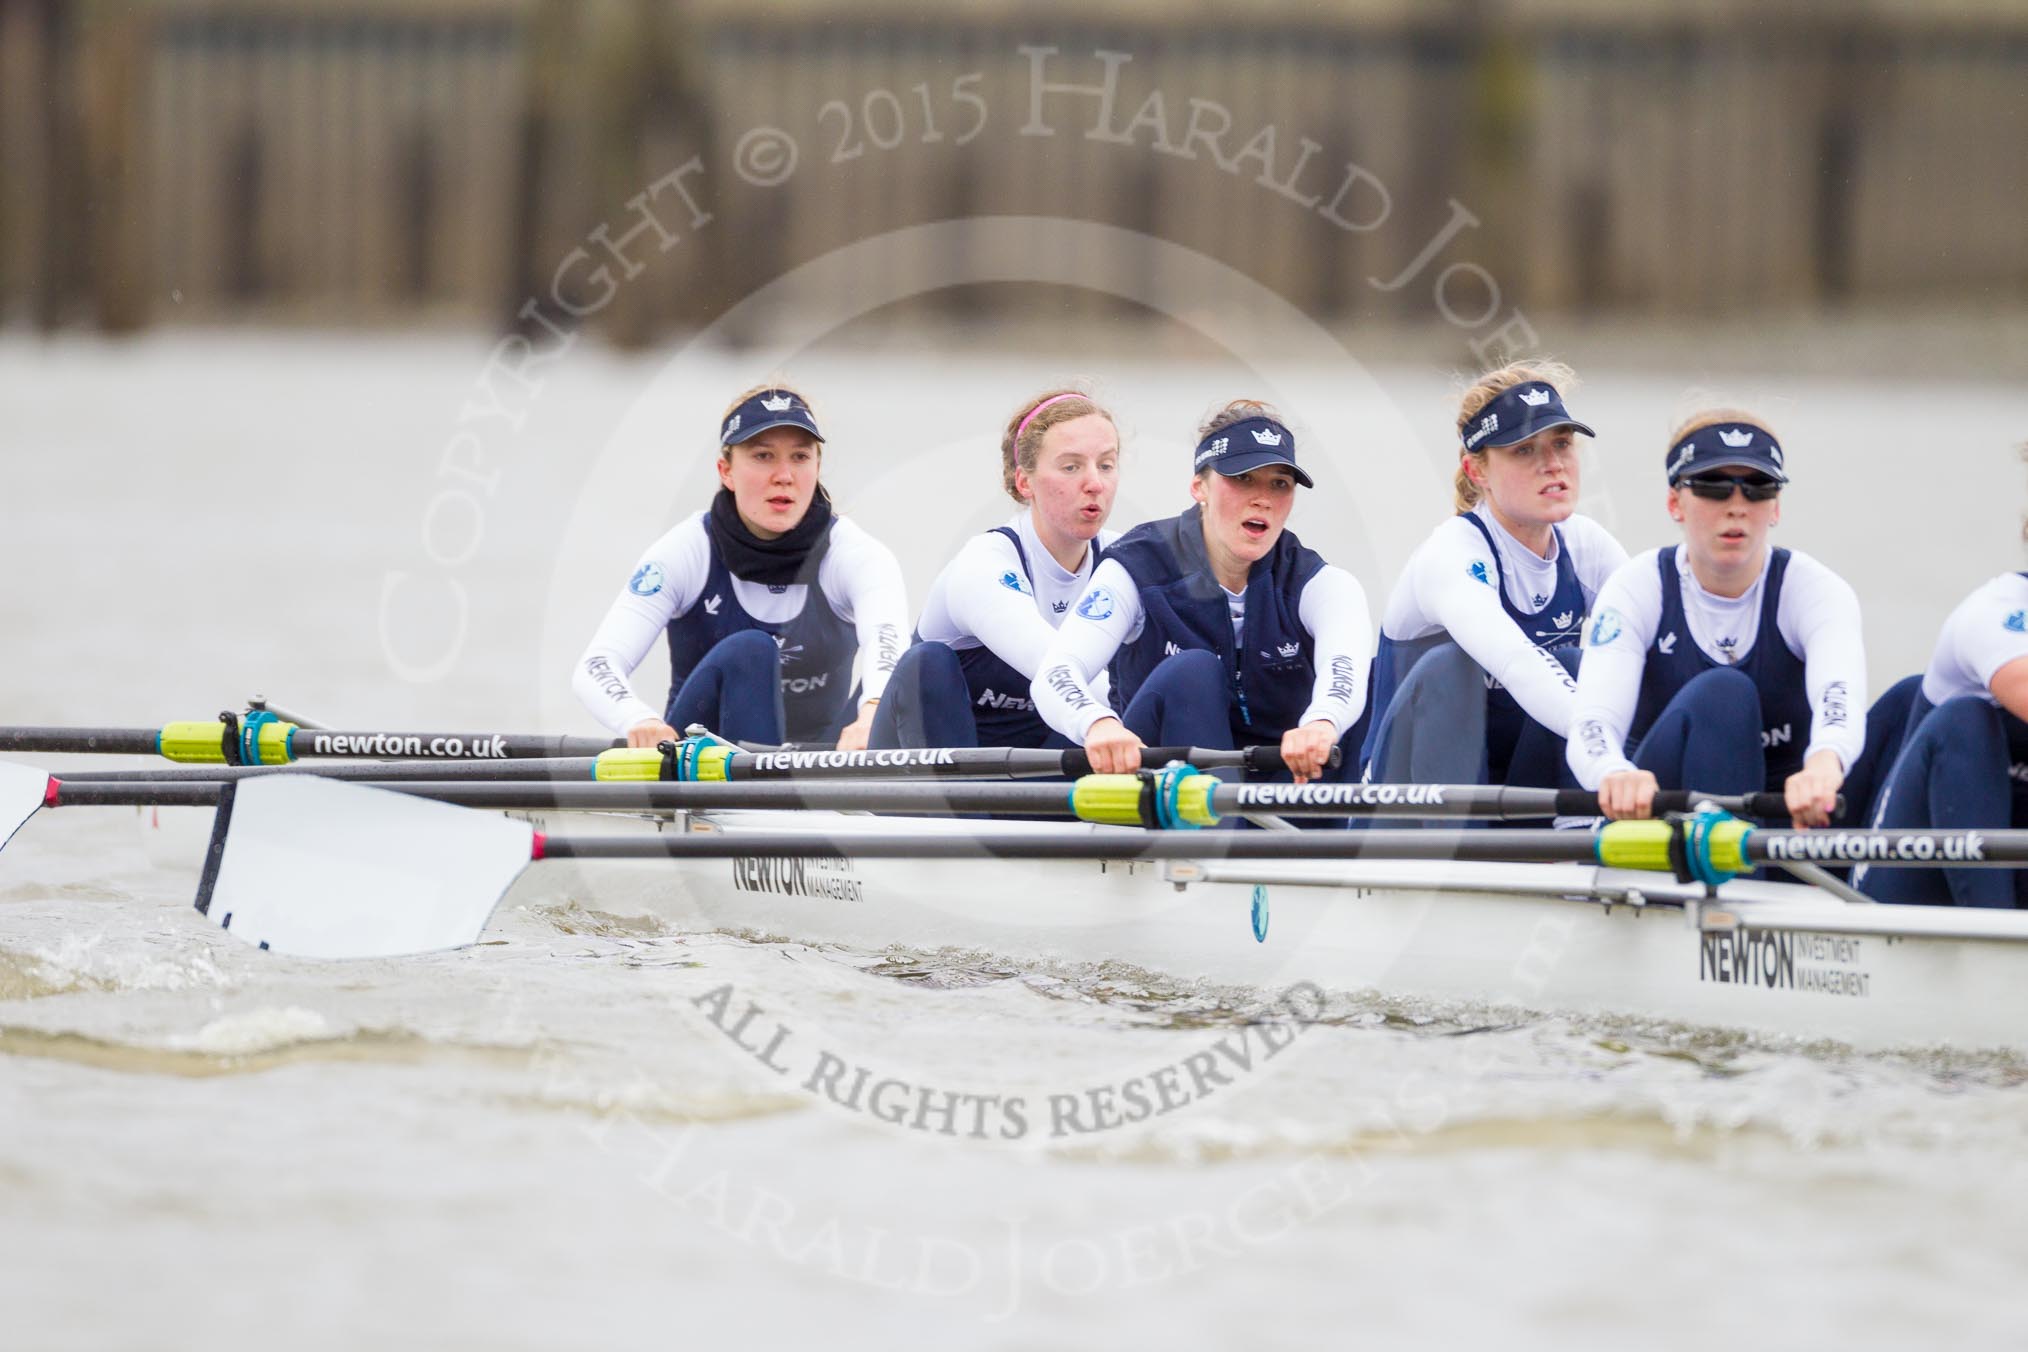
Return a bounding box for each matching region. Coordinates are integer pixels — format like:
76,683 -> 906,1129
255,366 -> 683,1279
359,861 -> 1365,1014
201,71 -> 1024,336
507,811 -> 2028,1050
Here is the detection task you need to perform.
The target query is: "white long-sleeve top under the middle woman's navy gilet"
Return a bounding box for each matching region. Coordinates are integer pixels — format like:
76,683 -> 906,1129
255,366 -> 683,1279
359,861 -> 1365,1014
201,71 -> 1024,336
1028,559 -> 1373,744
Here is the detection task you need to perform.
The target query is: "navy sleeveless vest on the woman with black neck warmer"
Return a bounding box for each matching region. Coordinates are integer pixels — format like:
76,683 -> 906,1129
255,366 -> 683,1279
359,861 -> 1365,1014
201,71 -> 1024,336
669,527 -> 860,742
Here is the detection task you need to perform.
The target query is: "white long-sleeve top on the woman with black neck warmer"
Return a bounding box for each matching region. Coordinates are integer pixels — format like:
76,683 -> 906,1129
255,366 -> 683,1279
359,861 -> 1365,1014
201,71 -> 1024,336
570,511 -> 909,734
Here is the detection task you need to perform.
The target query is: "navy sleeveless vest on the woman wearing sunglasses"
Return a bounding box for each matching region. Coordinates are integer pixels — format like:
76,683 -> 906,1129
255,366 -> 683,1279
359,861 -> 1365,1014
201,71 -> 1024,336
1626,545 -> 1811,793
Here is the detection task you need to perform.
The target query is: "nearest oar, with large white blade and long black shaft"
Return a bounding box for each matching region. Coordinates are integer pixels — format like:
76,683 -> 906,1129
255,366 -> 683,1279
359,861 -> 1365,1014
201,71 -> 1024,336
178,776 -> 2028,957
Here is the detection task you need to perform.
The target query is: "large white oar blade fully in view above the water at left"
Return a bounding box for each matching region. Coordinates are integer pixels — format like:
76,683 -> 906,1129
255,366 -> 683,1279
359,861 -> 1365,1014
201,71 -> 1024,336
197,774 -> 535,957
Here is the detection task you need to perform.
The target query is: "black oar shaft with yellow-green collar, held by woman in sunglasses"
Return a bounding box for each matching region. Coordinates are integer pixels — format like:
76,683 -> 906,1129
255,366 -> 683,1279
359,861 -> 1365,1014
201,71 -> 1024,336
43,764 -> 1781,829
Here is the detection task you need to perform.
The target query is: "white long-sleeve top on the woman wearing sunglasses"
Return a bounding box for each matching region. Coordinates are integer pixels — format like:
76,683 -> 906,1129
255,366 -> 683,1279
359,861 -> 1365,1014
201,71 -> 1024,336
1566,549 -> 1868,788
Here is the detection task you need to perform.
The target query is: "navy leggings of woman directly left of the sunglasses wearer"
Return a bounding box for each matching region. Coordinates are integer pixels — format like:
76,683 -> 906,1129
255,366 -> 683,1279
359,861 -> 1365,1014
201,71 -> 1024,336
1367,643 -> 1578,788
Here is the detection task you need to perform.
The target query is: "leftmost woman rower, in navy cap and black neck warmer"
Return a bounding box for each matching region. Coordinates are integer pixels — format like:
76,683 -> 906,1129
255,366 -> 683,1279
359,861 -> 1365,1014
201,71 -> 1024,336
570,385 -> 909,750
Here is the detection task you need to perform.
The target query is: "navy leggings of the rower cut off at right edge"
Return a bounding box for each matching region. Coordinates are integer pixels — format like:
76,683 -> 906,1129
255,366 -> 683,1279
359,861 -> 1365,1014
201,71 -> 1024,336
1854,695 -> 2028,906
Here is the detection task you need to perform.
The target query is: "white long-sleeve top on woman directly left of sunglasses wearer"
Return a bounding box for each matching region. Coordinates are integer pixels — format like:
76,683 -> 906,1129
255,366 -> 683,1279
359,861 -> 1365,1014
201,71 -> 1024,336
1381,505 -> 1626,736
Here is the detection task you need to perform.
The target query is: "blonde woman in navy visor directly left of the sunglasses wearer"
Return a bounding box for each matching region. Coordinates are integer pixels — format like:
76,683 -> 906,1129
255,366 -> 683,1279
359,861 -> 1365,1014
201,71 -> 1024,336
1365,361 -> 1626,802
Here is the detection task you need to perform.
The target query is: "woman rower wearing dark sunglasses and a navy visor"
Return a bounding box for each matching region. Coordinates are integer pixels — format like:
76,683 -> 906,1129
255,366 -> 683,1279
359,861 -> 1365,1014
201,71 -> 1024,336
1566,409 -> 1866,827
